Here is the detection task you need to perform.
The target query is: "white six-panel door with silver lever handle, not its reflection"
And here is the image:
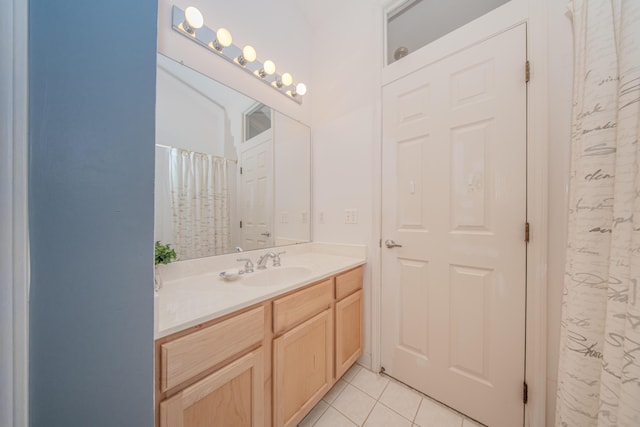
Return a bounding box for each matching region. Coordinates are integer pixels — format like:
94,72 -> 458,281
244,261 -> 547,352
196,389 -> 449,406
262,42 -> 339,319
381,25 -> 527,427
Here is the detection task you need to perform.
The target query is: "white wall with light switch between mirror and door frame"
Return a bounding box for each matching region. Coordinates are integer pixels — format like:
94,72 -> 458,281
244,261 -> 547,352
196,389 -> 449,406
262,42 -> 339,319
307,0 -> 383,363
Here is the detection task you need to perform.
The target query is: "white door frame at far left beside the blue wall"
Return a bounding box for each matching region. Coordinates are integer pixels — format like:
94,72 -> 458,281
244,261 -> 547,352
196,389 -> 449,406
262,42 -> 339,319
0,0 -> 29,426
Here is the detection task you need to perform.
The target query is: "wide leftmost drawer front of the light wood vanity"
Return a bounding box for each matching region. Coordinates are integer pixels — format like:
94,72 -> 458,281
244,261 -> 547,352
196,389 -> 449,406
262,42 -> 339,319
160,307 -> 264,391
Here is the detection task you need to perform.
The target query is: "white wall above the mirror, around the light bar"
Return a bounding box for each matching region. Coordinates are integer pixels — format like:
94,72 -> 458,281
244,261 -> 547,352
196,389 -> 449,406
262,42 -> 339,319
158,0 -> 315,124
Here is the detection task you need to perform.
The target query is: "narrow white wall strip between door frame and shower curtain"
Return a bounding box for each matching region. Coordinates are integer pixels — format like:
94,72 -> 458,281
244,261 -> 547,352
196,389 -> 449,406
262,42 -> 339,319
547,0 -> 573,426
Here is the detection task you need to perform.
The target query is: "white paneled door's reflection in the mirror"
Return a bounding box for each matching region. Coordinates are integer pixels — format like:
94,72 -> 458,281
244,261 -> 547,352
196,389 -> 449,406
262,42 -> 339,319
240,130 -> 273,250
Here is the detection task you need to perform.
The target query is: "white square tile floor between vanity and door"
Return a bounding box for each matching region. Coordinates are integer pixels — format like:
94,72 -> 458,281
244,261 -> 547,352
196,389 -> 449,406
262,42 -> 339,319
298,364 -> 480,427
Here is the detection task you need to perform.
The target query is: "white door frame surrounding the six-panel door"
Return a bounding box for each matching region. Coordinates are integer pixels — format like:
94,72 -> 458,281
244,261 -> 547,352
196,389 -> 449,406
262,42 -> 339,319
371,0 -> 549,426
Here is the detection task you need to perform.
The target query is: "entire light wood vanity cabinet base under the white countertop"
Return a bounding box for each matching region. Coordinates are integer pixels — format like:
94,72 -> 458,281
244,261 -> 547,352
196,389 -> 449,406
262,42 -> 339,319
155,267 -> 363,427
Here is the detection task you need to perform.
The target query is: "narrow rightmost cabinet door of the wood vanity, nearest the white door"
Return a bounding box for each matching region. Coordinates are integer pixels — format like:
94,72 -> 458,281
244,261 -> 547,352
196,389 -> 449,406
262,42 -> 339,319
336,289 -> 363,378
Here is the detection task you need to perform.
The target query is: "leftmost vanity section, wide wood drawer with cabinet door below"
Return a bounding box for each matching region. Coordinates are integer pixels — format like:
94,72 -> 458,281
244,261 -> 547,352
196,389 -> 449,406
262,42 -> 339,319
155,303 -> 272,427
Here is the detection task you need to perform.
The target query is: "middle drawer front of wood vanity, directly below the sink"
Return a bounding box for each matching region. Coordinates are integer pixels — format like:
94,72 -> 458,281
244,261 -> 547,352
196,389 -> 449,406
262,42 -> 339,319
273,278 -> 333,335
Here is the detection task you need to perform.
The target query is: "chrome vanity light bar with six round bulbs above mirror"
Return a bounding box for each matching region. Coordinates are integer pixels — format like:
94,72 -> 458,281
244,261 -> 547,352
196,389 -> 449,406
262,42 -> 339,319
172,5 -> 307,104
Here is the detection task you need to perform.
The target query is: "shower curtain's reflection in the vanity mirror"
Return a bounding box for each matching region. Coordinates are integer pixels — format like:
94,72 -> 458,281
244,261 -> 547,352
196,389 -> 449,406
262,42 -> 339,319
170,148 -> 231,260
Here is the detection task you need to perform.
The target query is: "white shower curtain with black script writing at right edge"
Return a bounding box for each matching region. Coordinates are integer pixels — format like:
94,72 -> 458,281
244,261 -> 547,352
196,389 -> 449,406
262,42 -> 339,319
556,0 -> 640,427
